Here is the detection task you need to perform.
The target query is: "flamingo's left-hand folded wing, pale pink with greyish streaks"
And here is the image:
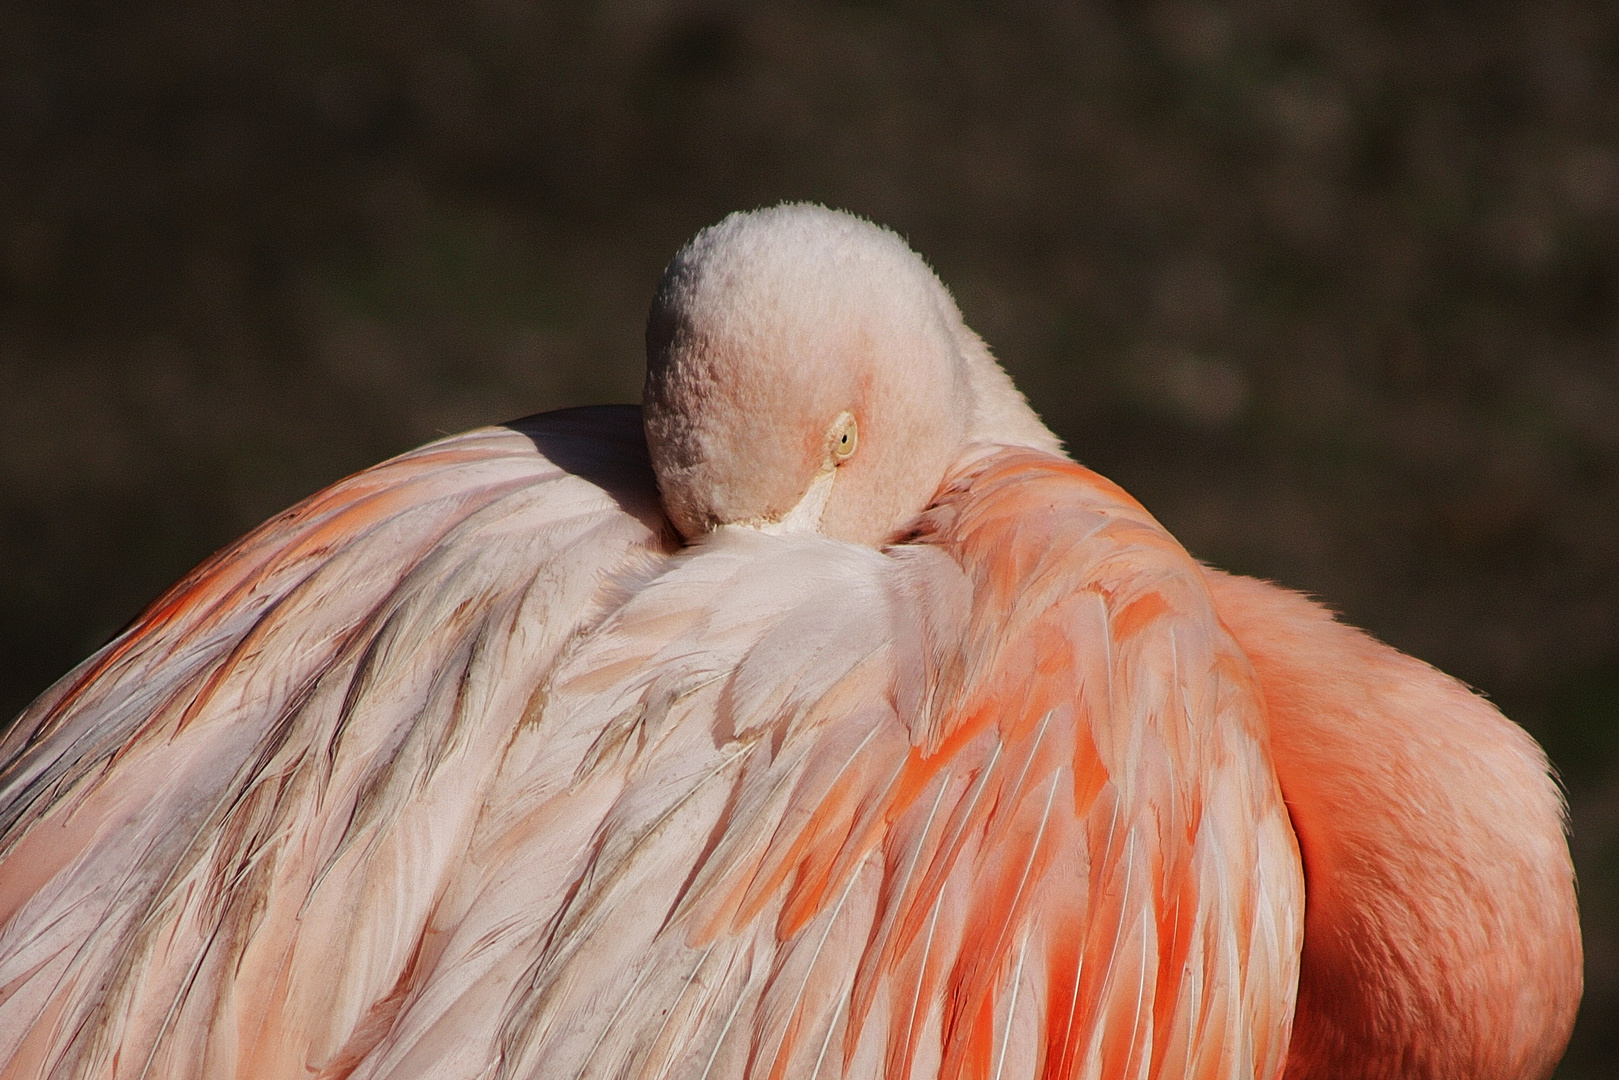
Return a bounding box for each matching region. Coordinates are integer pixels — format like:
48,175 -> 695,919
0,410 -> 665,1077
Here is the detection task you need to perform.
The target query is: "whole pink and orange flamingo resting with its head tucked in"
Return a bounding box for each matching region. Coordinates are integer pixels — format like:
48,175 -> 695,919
0,204 -> 1580,1080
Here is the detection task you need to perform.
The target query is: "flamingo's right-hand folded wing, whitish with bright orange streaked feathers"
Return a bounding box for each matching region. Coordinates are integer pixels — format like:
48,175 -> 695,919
355,453 -> 1302,1080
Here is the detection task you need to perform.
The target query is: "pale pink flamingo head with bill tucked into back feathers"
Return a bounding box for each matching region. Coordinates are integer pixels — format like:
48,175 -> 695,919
644,204 -> 1057,544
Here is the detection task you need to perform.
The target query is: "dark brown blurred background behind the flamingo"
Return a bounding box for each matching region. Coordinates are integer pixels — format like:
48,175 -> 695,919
0,0 -> 1619,1077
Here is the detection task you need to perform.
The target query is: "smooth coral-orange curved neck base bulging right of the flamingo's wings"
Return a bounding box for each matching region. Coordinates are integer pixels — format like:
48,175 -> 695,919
1206,570 -> 1582,1080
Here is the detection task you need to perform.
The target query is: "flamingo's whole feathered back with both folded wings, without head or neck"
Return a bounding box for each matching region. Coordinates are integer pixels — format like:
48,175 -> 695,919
0,430 -> 1302,1080
